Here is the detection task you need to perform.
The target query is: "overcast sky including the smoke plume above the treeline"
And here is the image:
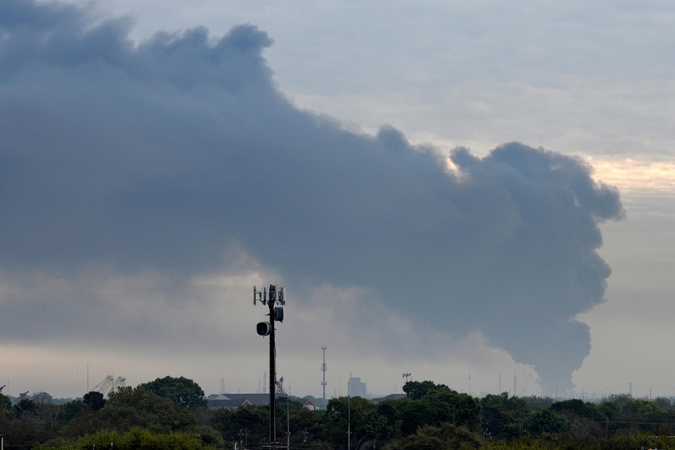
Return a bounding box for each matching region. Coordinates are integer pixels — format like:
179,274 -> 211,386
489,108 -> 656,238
0,0 -> 675,397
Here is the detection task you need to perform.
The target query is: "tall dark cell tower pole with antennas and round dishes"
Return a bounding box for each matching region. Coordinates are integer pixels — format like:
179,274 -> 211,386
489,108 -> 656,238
253,284 -> 286,449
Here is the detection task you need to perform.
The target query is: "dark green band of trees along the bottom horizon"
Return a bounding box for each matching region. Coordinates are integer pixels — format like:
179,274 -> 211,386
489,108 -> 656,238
0,377 -> 675,450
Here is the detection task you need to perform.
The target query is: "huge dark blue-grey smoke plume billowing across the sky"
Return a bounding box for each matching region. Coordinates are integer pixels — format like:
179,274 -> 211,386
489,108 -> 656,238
0,0 -> 623,391
